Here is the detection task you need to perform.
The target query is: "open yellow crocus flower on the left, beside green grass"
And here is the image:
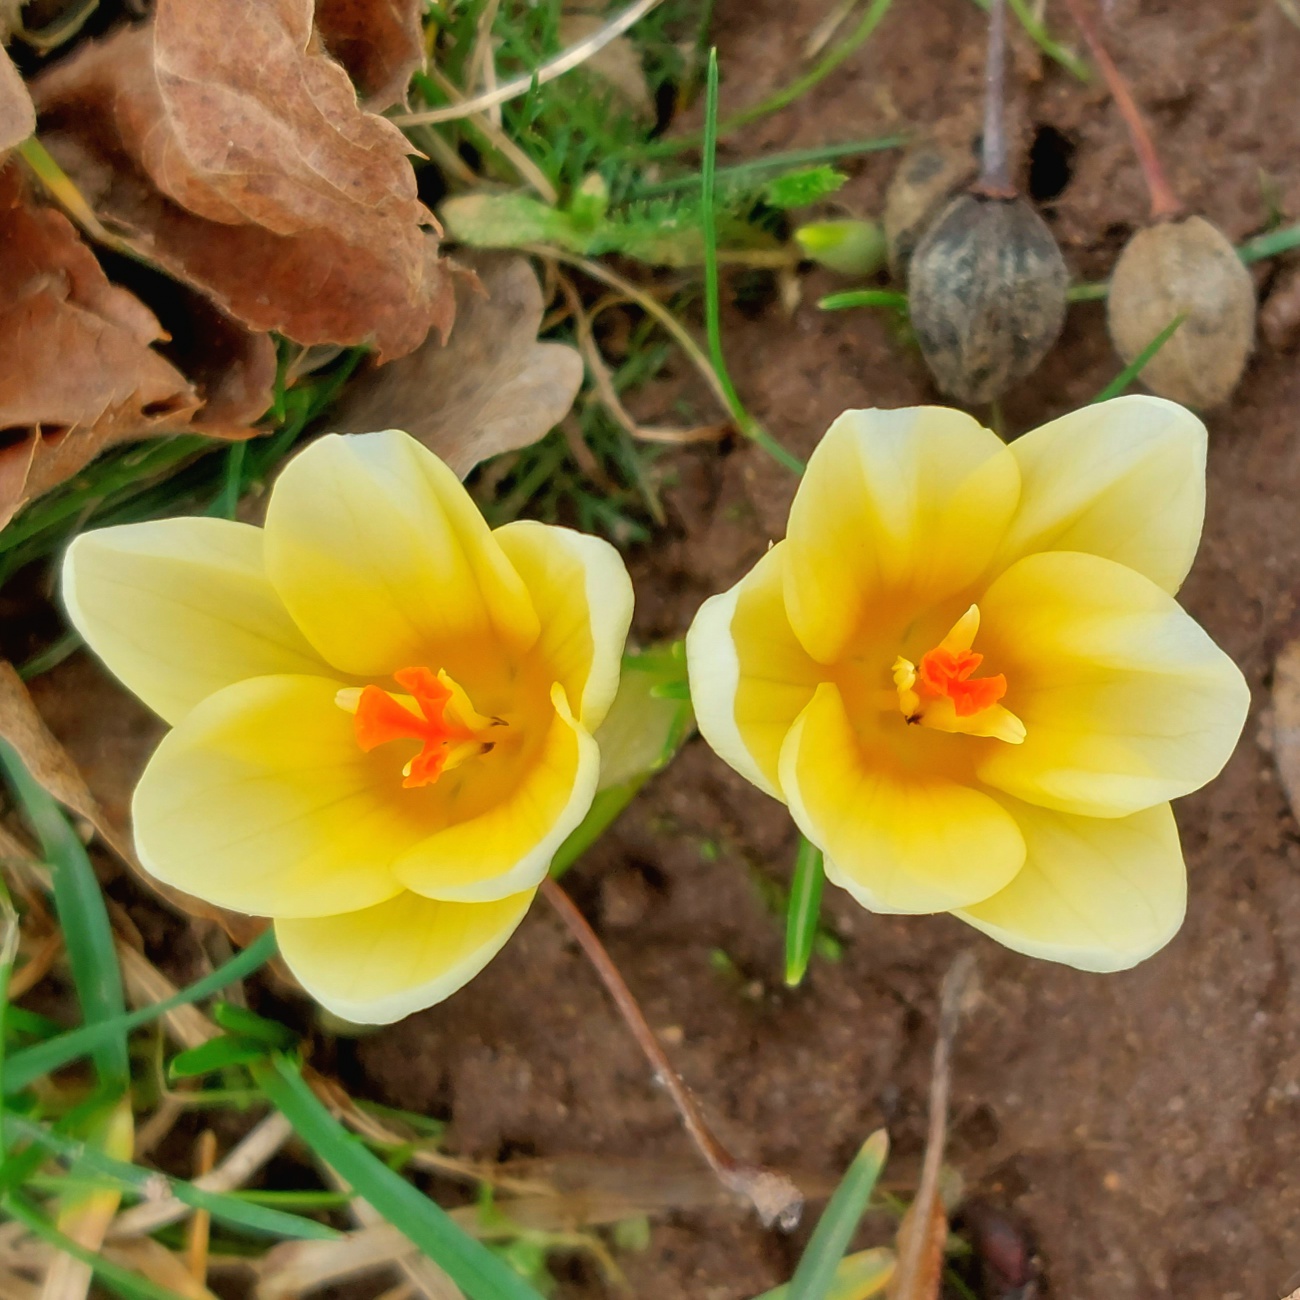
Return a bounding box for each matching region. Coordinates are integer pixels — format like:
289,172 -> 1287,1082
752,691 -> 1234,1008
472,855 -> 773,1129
64,430 -> 632,1023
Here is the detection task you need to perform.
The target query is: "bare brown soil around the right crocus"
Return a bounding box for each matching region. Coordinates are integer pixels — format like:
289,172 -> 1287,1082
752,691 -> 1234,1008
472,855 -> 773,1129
22,0 -> 1300,1300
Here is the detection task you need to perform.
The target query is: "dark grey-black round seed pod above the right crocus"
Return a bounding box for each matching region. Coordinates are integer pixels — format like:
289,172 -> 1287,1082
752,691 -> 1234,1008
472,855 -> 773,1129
907,194 -> 1069,403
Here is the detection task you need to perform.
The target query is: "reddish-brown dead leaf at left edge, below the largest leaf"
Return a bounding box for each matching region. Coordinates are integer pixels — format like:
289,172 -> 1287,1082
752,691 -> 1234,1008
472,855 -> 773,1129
0,164 -> 208,524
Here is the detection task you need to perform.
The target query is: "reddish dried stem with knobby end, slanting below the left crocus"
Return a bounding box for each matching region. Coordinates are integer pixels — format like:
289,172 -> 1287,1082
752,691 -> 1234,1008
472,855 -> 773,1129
542,878 -> 803,1227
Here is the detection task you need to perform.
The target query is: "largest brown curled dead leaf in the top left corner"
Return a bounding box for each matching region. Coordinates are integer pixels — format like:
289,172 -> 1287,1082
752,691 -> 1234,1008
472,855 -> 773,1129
33,0 -> 455,360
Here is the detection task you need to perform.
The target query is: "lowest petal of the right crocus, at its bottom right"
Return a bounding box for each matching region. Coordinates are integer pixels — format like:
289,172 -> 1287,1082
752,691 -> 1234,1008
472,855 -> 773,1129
957,801 -> 1187,971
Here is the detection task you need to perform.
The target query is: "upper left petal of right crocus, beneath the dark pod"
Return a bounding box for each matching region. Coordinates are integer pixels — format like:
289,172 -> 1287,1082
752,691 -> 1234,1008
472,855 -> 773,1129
785,407 -> 1021,663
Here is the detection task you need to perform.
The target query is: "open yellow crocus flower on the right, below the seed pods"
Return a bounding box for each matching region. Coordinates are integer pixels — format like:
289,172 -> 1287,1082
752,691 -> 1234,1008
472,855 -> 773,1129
686,397 -> 1249,971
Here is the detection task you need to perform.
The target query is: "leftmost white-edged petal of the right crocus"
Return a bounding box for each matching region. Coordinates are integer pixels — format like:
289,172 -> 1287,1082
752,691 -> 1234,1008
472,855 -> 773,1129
686,542 -> 822,798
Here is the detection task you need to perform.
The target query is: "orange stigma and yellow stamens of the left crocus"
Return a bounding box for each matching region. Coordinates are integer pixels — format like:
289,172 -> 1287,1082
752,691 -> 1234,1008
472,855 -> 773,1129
334,668 -> 506,789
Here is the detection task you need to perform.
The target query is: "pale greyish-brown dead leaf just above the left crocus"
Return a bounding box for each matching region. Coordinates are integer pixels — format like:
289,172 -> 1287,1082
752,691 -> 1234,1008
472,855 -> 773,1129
330,256 -> 582,477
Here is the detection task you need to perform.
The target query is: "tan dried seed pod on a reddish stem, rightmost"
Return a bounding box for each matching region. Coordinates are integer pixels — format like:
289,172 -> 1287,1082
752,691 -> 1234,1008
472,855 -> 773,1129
1106,217 -> 1255,411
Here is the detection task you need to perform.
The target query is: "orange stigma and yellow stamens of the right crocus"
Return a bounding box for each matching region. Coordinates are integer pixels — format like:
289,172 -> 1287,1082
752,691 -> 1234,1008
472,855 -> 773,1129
893,605 -> 1024,745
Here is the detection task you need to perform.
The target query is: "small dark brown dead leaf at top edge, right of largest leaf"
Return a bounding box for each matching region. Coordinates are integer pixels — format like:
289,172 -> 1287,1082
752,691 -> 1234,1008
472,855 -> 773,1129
316,0 -> 424,113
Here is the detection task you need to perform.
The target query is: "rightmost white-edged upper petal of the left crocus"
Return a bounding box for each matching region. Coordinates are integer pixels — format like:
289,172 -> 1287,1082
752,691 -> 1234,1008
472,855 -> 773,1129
493,519 -> 632,732
